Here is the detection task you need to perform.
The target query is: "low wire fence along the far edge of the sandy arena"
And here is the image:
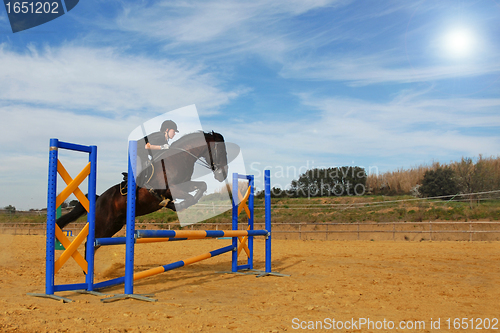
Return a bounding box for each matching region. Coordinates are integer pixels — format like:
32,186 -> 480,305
0,221 -> 500,241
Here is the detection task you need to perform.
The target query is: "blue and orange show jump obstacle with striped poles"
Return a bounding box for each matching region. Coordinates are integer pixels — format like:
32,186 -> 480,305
28,139 -> 286,302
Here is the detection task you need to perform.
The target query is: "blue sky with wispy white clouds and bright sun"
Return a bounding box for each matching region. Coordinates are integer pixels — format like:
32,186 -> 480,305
0,0 -> 500,209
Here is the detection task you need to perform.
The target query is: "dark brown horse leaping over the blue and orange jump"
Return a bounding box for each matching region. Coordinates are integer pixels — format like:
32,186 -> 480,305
56,132 -> 227,238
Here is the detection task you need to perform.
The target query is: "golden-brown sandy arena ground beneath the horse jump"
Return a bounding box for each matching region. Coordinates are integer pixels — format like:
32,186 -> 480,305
0,235 -> 500,332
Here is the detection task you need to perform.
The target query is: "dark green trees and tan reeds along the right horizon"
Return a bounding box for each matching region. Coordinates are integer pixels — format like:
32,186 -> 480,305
257,155 -> 500,198
